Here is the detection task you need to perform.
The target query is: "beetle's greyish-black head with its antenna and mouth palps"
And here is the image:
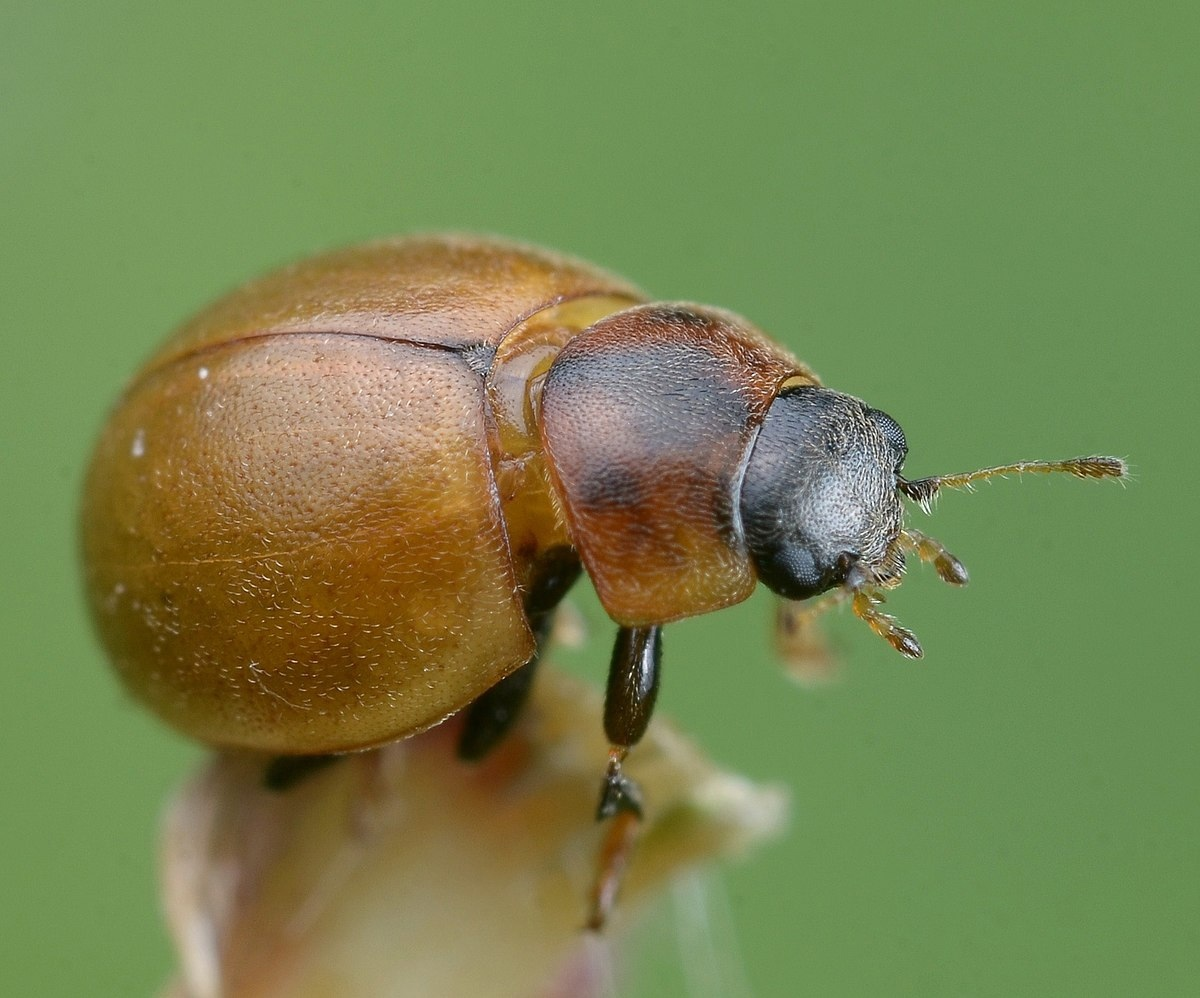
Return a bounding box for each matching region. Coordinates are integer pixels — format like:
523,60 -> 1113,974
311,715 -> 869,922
739,385 -> 1127,659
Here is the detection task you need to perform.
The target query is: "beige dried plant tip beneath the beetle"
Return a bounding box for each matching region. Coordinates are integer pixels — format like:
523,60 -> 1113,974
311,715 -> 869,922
163,668 -> 786,998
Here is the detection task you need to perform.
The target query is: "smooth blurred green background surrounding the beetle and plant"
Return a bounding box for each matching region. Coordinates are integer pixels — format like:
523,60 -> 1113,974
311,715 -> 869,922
0,0 -> 1200,996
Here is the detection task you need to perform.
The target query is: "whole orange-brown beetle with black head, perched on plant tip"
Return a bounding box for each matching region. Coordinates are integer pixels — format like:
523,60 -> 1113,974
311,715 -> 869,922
82,236 -> 1124,926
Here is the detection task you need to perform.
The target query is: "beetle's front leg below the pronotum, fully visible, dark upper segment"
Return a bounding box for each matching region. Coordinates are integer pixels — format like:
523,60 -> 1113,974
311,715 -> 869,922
588,626 -> 662,930
